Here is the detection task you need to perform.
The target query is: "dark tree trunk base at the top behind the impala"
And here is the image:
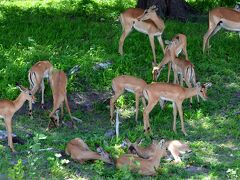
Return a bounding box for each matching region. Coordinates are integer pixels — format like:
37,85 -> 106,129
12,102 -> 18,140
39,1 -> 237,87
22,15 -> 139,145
137,0 -> 196,20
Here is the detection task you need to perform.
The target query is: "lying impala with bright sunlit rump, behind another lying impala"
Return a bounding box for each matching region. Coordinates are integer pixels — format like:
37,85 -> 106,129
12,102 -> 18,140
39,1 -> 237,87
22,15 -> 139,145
126,139 -> 191,163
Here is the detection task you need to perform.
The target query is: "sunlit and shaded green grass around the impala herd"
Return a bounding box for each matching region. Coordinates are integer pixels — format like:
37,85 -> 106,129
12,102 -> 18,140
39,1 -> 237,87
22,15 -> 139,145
0,0 -> 240,179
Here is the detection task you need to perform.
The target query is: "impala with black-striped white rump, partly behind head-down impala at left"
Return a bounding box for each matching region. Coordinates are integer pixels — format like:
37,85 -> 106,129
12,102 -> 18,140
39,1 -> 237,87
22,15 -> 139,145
28,61 -> 53,117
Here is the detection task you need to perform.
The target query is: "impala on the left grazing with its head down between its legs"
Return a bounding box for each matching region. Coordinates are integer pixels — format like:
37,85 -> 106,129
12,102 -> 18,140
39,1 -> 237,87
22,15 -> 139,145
48,70 -> 74,129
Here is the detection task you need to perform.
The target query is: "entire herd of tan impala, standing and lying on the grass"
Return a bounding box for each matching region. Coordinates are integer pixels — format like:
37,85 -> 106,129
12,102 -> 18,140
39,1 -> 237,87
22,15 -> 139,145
0,5 -> 240,175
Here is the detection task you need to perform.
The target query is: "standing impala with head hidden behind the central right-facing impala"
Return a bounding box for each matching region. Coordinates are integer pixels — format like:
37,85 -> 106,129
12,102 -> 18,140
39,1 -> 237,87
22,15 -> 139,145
110,75 -> 147,123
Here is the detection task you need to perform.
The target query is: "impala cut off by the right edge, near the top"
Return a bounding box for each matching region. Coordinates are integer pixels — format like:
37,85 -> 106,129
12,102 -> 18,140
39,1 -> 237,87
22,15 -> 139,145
203,7 -> 240,53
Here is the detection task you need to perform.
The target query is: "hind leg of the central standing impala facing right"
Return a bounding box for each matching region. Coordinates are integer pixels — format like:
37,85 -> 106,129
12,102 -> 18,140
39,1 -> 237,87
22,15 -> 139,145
143,100 -> 158,133
